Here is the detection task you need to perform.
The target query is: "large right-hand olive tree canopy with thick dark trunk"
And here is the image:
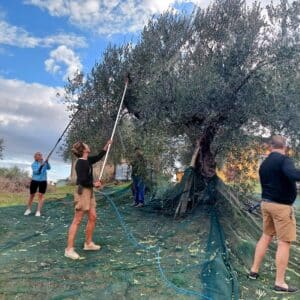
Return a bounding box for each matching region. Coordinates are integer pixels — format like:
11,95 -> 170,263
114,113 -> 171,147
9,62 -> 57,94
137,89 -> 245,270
128,0 -> 300,177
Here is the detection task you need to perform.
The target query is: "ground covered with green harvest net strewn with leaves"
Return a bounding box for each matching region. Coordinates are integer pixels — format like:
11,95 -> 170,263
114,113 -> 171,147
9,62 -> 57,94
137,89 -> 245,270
0,187 -> 300,300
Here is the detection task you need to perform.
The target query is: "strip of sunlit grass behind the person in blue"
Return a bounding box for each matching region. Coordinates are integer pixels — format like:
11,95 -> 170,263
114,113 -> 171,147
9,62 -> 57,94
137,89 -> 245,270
0,185 -> 74,207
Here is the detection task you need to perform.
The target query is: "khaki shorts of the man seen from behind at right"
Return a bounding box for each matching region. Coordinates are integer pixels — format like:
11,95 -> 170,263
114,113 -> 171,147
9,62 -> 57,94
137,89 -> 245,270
261,201 -> 296,242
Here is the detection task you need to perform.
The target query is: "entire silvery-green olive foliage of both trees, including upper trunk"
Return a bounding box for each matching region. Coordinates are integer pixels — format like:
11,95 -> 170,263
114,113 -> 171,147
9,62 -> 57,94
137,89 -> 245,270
63,0 -> 300,178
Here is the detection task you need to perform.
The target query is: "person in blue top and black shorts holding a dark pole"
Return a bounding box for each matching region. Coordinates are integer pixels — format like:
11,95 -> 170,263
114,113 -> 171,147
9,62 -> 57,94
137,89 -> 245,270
24,152 -> 51,217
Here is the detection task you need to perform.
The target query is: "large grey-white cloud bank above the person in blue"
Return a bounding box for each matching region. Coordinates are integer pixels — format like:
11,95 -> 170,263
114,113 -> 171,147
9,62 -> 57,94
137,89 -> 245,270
0,77 -> 69,161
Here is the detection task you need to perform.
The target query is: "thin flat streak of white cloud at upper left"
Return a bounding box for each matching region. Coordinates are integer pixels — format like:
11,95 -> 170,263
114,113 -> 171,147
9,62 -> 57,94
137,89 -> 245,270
0,19 -> 87,48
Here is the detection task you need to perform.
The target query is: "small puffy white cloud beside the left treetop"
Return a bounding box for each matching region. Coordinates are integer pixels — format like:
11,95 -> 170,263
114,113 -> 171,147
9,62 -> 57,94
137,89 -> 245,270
45,45 -> 82,80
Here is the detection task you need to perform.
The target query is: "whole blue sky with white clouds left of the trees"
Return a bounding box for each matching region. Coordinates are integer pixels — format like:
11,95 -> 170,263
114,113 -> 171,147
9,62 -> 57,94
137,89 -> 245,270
0,0 -> 276,181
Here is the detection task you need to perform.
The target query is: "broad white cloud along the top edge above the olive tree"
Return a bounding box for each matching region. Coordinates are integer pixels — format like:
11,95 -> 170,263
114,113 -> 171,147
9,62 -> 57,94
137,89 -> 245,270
24,0 -> 279,35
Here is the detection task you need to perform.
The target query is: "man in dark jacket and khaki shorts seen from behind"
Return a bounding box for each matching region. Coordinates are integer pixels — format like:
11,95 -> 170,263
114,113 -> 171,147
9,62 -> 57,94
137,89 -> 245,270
248,135 -> 300,293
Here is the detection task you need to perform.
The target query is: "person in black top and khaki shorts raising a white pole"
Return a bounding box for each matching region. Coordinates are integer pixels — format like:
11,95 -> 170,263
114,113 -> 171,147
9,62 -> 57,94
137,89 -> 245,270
65,140 -> 112,259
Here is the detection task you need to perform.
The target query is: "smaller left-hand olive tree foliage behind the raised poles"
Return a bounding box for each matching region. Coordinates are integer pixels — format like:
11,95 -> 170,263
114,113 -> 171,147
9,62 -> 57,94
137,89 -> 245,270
63,45 -> 176,171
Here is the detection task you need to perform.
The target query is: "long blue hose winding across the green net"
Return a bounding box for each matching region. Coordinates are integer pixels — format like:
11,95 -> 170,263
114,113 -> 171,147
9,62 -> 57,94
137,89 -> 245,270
99,192 -> 212,300
